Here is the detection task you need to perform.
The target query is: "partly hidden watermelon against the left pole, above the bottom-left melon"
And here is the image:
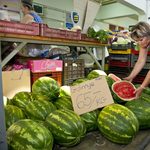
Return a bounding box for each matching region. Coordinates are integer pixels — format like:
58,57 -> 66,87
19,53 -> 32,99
4,105 -> 25,130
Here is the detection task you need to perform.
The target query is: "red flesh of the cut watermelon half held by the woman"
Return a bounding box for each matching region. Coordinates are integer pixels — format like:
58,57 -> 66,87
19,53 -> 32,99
113,81 -> 135,99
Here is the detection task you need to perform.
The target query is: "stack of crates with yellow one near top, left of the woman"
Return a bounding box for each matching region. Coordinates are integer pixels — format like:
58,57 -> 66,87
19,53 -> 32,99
109,43 -> 133,79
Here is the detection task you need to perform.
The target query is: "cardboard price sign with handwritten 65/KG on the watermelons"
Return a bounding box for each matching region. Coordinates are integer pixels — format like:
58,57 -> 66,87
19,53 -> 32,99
70,76 -> 114,115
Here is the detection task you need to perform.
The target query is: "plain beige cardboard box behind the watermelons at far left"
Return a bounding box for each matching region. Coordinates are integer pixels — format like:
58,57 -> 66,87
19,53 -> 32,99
2,70 -> 31,99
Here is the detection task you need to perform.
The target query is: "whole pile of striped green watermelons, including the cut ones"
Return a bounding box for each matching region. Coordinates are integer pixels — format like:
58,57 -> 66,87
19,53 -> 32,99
4,70 -> 150,150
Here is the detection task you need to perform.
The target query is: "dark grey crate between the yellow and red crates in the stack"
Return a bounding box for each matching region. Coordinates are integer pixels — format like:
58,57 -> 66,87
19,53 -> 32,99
109,53 -> 131,61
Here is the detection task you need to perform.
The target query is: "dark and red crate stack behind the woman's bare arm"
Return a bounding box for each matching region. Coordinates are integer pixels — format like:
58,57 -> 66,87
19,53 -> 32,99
131,49 -> 150,83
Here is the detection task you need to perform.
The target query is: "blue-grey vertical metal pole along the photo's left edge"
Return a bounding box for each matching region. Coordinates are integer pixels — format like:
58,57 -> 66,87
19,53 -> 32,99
0,37 -> 7,150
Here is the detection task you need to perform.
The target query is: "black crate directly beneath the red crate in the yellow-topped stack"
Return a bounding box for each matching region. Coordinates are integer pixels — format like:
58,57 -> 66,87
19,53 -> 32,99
109,65 -> 131,75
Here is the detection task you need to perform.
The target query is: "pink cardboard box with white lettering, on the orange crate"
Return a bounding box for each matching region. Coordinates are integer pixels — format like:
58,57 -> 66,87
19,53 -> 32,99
27,59 -> 63,72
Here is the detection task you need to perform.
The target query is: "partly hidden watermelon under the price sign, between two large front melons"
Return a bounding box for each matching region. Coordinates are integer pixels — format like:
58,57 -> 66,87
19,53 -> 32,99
80,109 -> 100,131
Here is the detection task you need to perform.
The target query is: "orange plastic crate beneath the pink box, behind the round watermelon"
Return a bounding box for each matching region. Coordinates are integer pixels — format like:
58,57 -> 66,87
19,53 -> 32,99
31,71 -> 62,89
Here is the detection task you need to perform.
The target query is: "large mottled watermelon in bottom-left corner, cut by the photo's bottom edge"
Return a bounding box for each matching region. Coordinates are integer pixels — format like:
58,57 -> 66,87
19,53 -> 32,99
6,119 -> 54,150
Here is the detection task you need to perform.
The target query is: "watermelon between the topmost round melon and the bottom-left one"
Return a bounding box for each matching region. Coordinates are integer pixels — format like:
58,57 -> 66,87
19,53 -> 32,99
24,100 -> 56,123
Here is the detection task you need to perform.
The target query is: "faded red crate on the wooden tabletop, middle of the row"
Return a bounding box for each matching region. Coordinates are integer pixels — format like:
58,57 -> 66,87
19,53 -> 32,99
39,23 -> 81,40
